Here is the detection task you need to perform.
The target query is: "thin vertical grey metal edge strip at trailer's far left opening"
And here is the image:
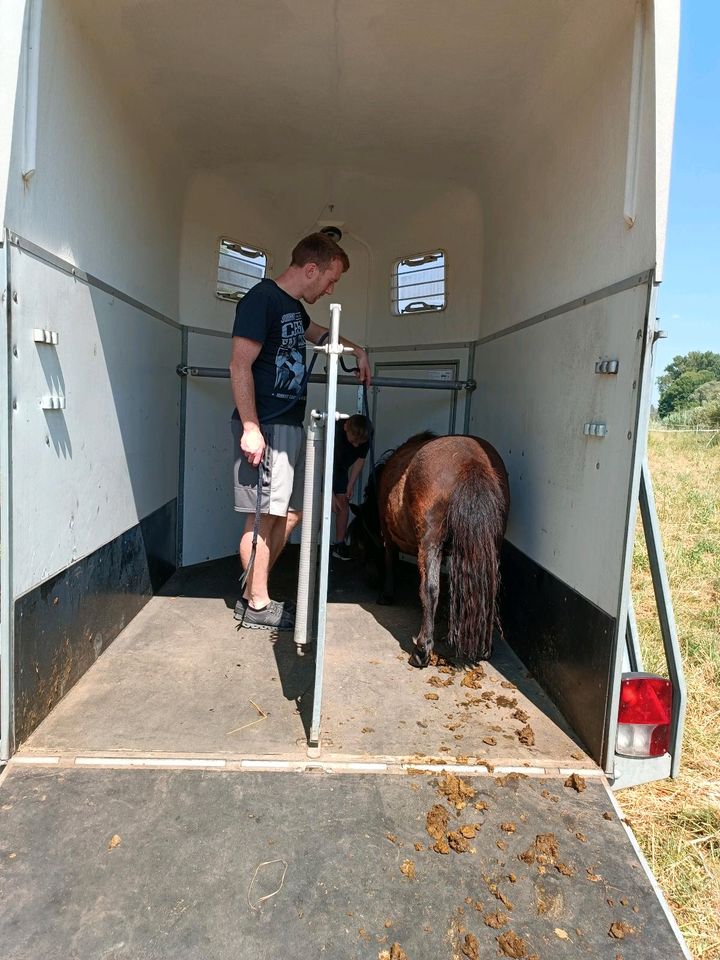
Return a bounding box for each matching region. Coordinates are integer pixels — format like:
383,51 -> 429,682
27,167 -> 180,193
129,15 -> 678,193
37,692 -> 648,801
0,230 -> 15,761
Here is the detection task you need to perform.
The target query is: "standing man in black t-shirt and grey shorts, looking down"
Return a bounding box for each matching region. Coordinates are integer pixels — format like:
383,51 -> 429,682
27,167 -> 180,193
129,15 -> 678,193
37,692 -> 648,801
230,233 -> 370,630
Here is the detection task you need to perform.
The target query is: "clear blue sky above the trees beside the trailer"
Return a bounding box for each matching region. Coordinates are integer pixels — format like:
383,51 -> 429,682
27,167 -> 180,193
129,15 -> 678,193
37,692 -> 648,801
653,0 -> 720,398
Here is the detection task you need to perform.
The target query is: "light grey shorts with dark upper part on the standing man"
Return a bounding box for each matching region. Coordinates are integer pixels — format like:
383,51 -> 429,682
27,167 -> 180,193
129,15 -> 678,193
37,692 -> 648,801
230,420 -> 305,517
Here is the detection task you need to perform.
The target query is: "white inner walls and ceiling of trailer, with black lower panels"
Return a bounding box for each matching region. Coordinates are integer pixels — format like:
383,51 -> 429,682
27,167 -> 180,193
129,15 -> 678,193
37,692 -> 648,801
0,0 -> 679,782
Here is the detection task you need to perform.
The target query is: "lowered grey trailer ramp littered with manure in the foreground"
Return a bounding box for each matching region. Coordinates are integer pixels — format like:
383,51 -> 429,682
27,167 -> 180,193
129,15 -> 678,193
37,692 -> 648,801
0,763 -> 684,960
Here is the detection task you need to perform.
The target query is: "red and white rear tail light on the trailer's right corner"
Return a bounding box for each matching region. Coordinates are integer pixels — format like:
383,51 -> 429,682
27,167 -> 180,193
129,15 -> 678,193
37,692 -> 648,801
616,673 -> 672,757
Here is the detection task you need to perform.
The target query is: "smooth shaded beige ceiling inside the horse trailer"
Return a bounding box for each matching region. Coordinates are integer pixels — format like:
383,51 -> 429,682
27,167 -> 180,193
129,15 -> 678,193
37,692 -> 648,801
67,0 -> 634,181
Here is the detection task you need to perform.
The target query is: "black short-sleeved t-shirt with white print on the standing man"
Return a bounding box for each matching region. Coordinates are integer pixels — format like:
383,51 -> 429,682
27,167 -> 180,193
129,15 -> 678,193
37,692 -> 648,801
233,279 -> 310,424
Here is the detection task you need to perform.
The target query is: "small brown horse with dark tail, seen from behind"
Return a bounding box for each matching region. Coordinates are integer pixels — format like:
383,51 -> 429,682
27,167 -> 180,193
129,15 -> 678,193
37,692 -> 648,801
351,433 -> 510,667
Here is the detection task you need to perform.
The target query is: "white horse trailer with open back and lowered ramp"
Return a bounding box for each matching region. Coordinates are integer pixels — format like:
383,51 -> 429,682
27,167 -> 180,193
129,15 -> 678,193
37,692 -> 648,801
0,0 -> 687,958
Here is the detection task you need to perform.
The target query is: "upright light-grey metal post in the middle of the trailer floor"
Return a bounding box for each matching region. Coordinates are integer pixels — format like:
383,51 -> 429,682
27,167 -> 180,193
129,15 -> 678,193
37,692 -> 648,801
308,303 -> 343,756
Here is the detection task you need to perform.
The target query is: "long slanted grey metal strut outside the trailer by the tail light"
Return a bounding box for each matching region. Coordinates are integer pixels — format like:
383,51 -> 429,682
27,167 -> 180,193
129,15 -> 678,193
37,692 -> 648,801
640,459 -> 687,777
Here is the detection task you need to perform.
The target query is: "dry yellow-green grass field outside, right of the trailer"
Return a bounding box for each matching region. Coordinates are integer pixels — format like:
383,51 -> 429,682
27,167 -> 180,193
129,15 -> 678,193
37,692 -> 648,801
618,433 -> 720,960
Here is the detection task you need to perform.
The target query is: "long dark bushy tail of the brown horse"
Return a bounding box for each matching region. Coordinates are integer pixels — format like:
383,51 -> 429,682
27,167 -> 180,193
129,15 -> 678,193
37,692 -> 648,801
447,463 -> 506,660
